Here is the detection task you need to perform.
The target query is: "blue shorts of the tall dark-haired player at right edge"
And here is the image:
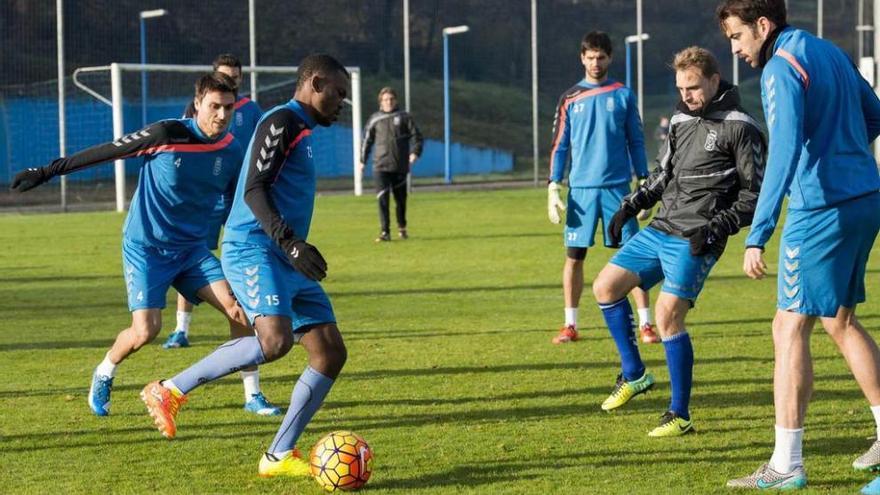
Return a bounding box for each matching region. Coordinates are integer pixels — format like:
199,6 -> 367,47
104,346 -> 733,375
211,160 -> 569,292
776,193 -> 880,317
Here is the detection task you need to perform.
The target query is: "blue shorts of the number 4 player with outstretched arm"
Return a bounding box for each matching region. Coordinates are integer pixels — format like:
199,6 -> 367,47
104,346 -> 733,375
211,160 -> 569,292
122,238 -> 225,311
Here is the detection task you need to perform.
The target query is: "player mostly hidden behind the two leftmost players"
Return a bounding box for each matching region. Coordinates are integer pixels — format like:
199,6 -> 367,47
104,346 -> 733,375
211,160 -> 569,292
162,53 -> 262,348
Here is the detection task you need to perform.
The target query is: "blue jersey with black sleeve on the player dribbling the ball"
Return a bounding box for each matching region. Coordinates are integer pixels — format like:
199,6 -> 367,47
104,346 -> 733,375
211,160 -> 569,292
223,100 -> 316,259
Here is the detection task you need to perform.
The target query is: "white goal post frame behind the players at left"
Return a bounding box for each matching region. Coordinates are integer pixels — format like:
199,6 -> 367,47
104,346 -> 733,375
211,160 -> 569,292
72,63 -> 363,211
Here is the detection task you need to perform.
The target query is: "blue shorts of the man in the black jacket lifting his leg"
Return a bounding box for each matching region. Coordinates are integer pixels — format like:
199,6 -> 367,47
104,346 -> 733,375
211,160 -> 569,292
609,227 -> 718,303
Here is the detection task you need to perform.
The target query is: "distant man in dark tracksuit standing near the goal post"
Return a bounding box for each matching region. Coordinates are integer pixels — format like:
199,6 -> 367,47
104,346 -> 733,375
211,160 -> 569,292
360,86 -> 422,242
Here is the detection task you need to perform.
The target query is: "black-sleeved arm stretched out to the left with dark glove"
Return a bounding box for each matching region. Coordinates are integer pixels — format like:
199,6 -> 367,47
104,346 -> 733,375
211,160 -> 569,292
12,121 -> 177,192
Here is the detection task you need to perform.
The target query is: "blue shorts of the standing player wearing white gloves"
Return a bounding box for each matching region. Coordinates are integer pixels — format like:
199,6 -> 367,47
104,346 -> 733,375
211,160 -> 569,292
564,184 -> 639,247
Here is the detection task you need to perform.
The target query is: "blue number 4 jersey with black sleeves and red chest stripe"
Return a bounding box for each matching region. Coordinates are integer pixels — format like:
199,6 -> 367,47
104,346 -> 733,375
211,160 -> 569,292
39,119 -> 242,249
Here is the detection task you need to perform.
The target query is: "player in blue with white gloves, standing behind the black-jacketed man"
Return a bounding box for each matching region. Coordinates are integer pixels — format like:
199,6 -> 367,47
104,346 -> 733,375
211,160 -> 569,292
547,31 -> 659,344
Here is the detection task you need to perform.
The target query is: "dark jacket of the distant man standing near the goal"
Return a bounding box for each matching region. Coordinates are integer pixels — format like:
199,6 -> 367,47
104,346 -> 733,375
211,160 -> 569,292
361,110 -> 422,174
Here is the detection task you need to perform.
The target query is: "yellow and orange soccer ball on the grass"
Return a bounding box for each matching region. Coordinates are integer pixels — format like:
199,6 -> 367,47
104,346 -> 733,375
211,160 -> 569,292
309,431 -> 373,492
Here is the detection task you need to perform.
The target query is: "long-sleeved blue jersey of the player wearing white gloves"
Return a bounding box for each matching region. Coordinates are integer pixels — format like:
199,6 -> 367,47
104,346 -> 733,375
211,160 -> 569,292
550,79 -> 648,187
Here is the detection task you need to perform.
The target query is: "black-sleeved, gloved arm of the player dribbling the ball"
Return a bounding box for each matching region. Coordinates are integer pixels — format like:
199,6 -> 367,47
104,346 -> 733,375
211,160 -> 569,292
244,110 -> 327,280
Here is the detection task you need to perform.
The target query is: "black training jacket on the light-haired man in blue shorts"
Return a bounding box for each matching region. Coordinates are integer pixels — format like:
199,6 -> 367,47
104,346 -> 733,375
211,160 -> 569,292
623,81 -> 767,256
